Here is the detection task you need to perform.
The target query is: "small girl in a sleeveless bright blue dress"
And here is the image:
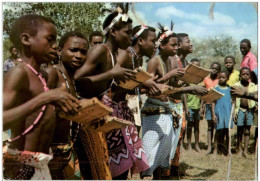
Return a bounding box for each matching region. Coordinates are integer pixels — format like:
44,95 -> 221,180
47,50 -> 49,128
212,71 -> 233,155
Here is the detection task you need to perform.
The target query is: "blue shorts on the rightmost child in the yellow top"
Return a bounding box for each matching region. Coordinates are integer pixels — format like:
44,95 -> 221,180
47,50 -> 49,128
237,109 -> 254,126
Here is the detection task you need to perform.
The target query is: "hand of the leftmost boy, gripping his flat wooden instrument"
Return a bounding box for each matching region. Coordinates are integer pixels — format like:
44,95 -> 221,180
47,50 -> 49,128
45,83 -> 80,113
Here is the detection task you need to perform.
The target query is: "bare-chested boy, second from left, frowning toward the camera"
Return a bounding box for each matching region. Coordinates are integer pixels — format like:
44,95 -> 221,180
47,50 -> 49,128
46,31 -> 88,180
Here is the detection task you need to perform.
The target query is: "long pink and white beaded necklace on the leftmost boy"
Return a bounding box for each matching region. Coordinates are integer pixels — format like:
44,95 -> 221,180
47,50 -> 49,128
7,59 -> 49,143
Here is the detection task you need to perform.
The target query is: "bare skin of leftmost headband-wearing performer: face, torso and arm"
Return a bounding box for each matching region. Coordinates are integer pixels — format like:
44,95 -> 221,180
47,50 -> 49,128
75,23 -> 135,97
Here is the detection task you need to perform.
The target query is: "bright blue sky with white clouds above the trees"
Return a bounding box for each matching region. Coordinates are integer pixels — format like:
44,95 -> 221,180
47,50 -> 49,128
129,2 -> 258,45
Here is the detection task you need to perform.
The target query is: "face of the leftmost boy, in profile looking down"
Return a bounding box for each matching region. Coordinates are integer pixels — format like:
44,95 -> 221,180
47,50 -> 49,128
29,22 -> 57,63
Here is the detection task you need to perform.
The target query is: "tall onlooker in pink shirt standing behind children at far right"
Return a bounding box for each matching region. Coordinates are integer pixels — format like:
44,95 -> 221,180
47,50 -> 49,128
240,39 -> 258,83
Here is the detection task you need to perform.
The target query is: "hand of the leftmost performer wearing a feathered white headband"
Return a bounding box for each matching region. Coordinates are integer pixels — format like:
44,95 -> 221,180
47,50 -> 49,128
111,64 -> 136,82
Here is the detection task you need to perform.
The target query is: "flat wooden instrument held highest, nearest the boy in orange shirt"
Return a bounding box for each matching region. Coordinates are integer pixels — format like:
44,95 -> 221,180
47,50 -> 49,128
179,63 -> 211,84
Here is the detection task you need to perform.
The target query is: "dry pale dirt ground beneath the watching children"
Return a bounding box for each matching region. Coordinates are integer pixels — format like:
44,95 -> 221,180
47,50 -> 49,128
128,120 -> 257,180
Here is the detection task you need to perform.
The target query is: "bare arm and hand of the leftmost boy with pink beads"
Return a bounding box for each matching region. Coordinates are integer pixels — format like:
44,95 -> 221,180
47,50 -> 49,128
3,66 -> 79,129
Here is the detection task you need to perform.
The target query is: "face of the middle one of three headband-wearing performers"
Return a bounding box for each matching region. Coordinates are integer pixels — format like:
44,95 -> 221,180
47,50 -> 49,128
142,31 -> 156,58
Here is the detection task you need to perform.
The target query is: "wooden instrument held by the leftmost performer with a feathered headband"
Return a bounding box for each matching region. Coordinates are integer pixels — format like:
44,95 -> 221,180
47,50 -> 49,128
119,67 -> 153,90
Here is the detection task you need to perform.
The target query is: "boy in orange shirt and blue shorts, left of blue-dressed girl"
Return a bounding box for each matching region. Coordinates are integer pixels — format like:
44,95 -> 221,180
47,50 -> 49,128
203,62 -> 221,154
